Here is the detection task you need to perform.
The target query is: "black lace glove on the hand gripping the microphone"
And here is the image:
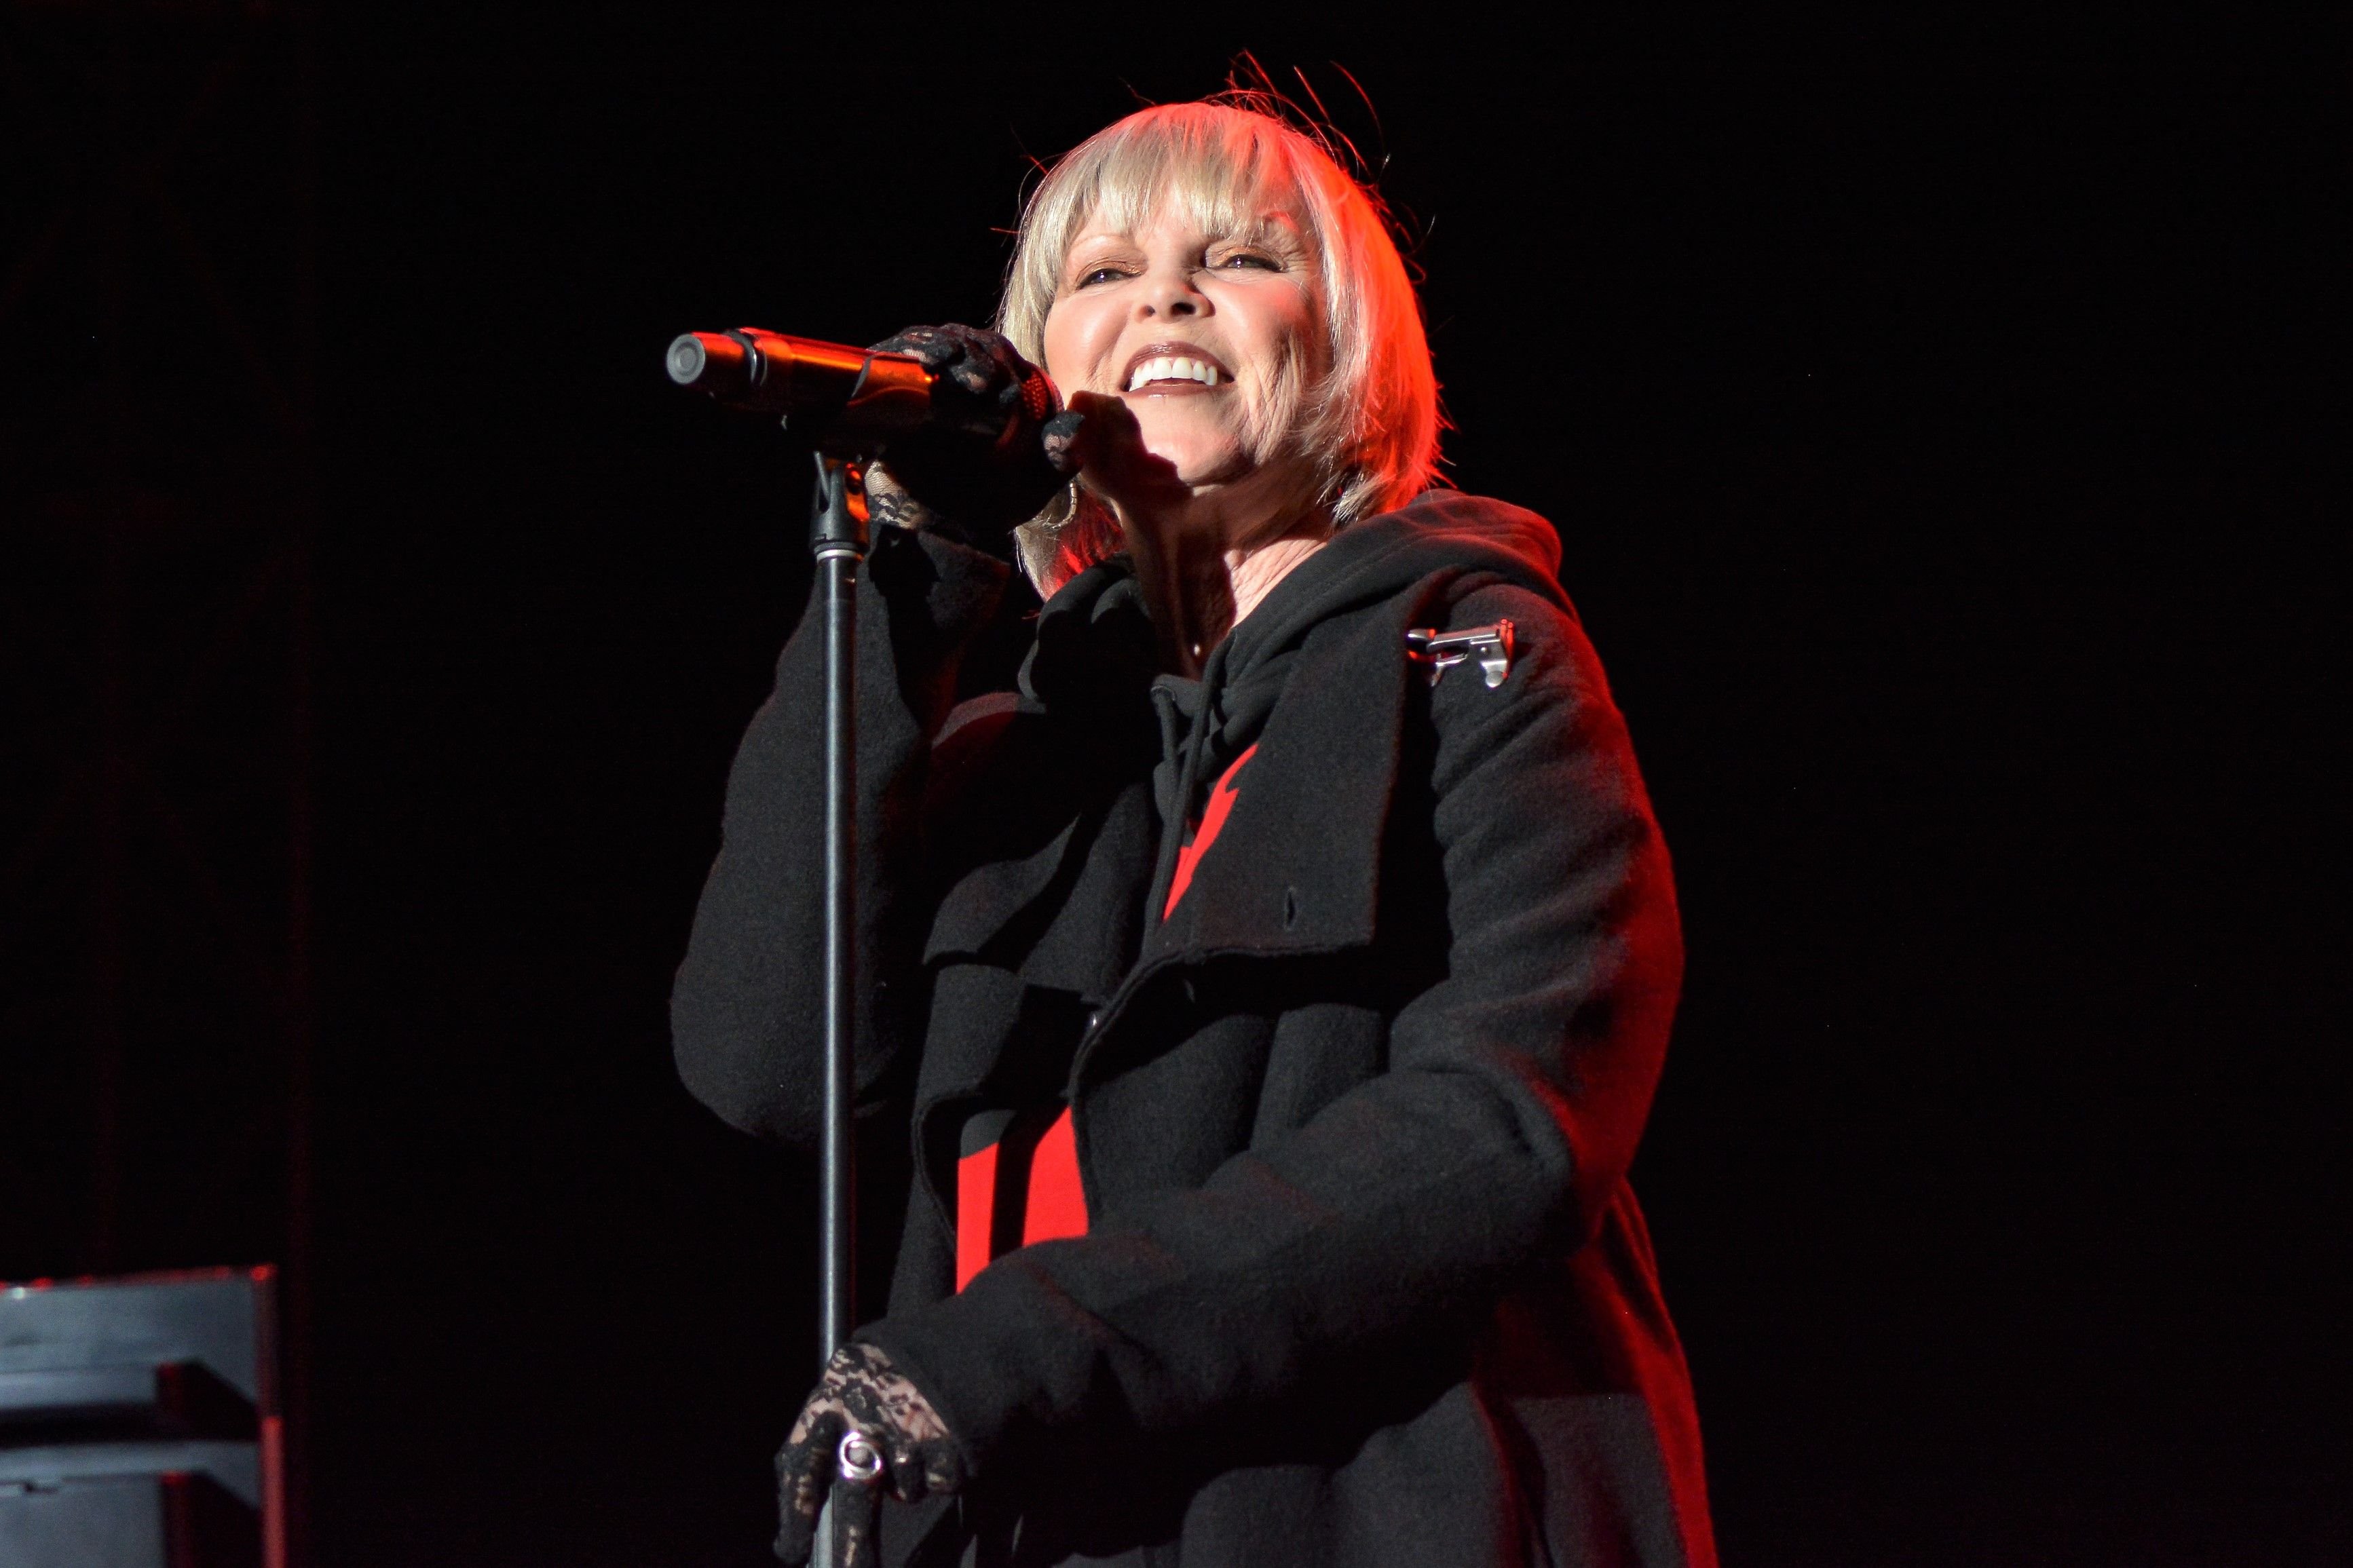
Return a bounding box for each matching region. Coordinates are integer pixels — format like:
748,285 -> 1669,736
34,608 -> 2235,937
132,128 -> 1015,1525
868,324 -> 1083,548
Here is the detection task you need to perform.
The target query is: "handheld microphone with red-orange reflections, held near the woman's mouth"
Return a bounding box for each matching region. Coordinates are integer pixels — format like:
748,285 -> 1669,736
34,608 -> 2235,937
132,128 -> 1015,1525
666,327 -> 1057,456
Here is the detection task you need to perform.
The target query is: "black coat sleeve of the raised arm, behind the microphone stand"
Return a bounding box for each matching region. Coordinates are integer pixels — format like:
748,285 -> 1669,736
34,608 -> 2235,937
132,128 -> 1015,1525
671,527 -> 1012,1145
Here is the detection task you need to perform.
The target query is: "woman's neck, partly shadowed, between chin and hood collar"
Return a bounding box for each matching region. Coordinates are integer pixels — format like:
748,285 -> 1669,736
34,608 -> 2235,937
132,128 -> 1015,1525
1120,491 -> 1332,674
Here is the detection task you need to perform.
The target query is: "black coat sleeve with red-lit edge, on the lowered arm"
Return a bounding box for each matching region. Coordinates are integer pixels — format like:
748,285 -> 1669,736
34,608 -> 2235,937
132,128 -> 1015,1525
861,588 -> 1682,1472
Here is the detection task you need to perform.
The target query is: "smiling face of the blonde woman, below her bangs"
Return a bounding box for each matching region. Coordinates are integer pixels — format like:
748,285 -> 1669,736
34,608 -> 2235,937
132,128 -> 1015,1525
1044,202 -> 1325,501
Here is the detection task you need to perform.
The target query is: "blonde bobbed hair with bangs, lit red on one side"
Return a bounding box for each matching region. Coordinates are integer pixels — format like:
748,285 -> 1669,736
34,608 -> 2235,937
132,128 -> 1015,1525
998,94 -> 1440,592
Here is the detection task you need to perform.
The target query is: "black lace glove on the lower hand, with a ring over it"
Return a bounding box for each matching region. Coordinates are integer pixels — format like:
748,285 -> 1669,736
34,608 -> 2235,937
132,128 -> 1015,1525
776,1345 -> 964,1568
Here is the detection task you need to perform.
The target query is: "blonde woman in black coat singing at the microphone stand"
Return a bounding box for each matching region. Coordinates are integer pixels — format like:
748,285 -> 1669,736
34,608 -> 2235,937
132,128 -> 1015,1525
673,96 -> 1715,1568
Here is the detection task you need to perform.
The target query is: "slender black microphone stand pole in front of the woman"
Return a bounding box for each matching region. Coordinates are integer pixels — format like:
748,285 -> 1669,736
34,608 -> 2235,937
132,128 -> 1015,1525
810,451 -> 871,1568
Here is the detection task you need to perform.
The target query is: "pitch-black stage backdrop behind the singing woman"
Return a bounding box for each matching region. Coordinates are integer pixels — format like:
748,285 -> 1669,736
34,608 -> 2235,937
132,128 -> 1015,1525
0,5 -> 2353,1568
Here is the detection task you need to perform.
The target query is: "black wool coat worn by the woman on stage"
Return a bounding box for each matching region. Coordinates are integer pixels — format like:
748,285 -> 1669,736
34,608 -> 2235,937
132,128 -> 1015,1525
673,491 -> 1715,1568
